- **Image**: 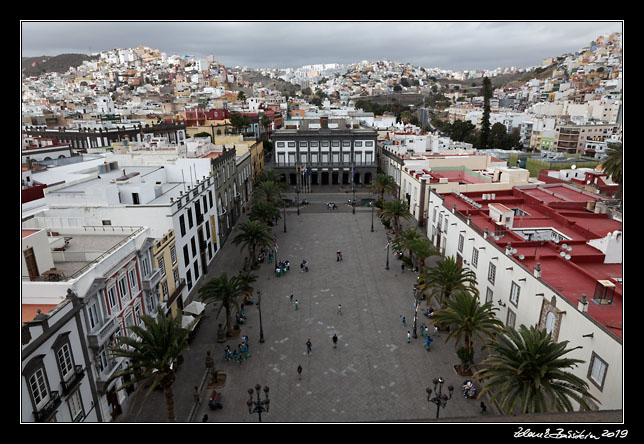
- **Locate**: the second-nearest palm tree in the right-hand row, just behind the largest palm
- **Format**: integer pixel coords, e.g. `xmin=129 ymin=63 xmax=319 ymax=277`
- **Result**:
xmin=432 ymin=291 xmax=503 ymax=370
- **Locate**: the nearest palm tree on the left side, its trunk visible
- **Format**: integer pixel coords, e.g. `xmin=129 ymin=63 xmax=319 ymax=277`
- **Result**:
xmin=108 ymin=312 xmax=196 ymax=422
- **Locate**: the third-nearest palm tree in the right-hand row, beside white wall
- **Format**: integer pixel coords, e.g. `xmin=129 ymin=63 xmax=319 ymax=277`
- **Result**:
xmin=419 ymin=256 xmax=479 ymax=306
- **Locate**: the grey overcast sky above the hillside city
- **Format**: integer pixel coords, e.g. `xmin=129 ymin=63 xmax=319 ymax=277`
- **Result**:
xmin=21 ymin=21 xmax=623 ymax=71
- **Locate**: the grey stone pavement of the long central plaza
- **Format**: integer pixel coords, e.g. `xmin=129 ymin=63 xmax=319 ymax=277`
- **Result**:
xmin=118 ymin=193 xmax=492 ymax=423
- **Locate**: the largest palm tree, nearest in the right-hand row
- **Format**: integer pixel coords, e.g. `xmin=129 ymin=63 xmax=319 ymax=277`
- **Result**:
xmin=474 ymin=325 xmax=597 ymax=414
